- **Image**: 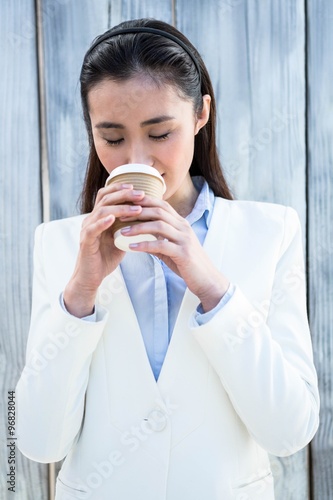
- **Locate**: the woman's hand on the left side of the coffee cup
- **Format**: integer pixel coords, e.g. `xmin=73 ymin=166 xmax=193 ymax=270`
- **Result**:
xmin=64 ymin=184 xmax=144 ymax=317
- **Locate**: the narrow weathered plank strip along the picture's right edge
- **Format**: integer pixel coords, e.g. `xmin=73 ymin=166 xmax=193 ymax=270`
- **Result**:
xmin=307 ymin=0 xmax=333 ymax=500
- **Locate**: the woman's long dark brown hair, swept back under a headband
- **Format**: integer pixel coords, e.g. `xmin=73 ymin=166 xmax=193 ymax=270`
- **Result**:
xmin=80 ymin=19 xmax=232 ymax=213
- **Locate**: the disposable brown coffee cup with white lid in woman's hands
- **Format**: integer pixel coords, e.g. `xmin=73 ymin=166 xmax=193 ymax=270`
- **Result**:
xmin=105 ymin=163 xmax=166 ymax=252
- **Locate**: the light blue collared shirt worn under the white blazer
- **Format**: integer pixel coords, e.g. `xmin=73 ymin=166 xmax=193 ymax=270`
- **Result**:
xmin=61 ymin=177 xmax=235 ymax=380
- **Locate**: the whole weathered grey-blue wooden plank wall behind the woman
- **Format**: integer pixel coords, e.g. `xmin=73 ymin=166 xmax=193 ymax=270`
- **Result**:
xmin=0 ymin=0 xmax=333 ymax=500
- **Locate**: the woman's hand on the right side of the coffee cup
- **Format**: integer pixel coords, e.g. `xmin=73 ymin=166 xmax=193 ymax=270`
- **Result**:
xmin=116 ymin=196 xmax=229 ymax=312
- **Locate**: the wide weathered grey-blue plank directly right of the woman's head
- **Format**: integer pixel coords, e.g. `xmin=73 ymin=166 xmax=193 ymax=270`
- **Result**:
xmin=176 ymin=0 xmax=309 ymax=500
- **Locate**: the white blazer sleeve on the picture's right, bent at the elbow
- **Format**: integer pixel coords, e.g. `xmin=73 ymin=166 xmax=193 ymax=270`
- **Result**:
xmin=190 ymin=207 xmax=319 ymax=456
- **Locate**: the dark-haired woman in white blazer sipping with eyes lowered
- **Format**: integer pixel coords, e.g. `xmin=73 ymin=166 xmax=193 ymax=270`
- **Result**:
xmin=17 ymin=19 xmax=319 ymax=500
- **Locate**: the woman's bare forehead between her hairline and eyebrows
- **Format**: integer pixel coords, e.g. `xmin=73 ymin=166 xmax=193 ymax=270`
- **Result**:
xmin=88 ymin=77 xmax=193 ymax=121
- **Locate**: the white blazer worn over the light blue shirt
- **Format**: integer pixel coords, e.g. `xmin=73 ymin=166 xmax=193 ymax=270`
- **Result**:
xmin=16 ymin=198 xmax=319 ymax=500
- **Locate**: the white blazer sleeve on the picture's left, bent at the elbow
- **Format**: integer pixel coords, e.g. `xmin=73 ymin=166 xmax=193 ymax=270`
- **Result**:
xmin=16 ymin=225 xmax=107 ymax=463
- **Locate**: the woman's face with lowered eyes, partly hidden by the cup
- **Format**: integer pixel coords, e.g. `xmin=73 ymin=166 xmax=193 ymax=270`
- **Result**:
xmin=88 ymin=77 xmax=210 ymax=209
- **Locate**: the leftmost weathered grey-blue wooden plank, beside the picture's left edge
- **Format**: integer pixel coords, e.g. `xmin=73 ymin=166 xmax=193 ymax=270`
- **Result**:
xmin=0 ymin=0 xmax=47 ymax=500
